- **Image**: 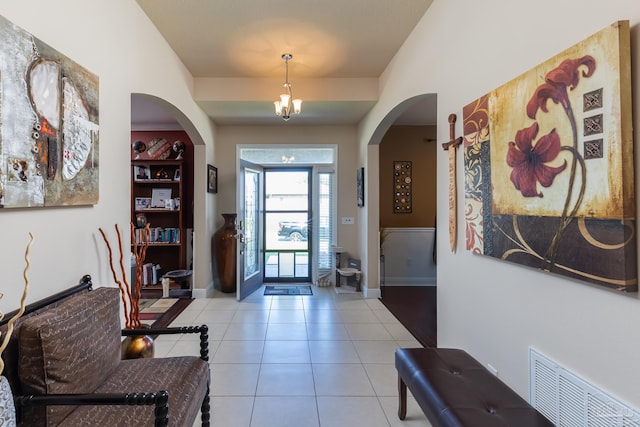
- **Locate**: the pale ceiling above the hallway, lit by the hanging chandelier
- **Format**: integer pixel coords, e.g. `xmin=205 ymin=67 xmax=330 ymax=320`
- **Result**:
xmin=132 ymin=0 xmax=435 ymax=126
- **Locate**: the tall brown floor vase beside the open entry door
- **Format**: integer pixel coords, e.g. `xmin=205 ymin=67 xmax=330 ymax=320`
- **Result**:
xmin=211 ymin=214 xmax=237 ymax=292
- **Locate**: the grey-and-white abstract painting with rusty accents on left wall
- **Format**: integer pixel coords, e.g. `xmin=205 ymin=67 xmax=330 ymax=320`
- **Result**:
xmin=0 ymin=16 xmax=99 ymax=208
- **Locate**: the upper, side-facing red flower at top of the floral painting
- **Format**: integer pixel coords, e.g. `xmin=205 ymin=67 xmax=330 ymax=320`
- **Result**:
xmin=527 ymin=55 xmax=596 ymax=119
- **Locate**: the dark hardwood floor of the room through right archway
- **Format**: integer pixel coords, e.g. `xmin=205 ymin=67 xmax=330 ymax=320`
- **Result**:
xmin=380 ymin=286 xmax=438 ymax=347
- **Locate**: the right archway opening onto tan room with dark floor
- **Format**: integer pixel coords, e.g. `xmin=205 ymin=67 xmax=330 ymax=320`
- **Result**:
xmin=369 ymin=94 xmax=438 ymax=346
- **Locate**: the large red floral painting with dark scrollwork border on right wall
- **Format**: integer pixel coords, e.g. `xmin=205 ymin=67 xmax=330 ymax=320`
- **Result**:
xmin=463 ymin=21 xmax=638 ymax=292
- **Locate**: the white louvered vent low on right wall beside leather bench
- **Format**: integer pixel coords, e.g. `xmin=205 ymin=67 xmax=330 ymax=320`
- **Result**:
xmin=529 ymin=348 xmax=640 ymax=427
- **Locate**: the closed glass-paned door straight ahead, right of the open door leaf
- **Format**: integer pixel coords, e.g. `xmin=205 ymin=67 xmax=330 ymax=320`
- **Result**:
xmin=264 ymin=168 xmax=312 ymax=282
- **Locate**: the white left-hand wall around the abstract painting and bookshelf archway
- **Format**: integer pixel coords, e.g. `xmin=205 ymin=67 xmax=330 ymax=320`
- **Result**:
xmin=0 ymin=0 xmax=214 ymax=311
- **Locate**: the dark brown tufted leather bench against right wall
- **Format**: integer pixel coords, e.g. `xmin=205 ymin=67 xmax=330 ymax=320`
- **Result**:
xmin=395 ymin=348 xmax=553 ymax=427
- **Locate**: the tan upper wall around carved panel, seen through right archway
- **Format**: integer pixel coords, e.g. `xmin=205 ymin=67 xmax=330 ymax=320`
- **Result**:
xmin=379 ymin=126 xmax=437 ymax=228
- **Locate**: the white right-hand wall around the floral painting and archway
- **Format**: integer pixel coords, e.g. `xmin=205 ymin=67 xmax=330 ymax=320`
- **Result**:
xmin=360 ymin=0 xmax=640 ymax=408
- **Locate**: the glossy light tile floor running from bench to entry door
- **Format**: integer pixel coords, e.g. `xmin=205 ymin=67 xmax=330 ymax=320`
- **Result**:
xmin=156 ymin=287 xmax=430 ymax=427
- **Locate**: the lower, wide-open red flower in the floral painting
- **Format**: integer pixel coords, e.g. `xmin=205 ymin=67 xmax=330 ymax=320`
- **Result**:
xmin=507 ymin=122 xmax=567 ymax=197
